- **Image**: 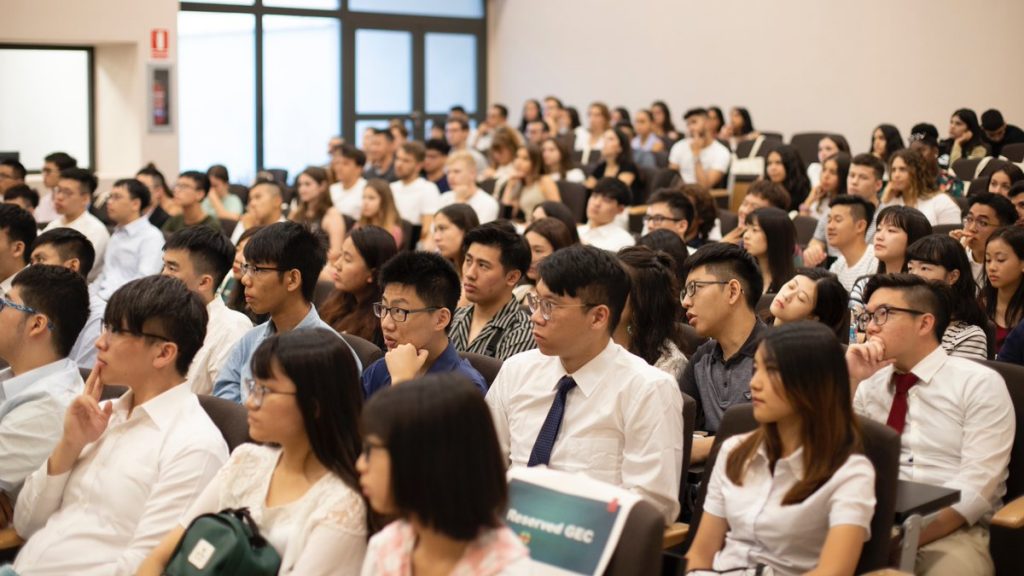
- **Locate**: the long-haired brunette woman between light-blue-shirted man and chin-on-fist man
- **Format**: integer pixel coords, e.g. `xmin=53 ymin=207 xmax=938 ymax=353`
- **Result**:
xmin=317 ymin=225 xmax=398 ymax=348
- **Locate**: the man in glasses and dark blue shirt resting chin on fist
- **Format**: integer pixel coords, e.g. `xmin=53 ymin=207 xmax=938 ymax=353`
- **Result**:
xmin=362 ymin=252 xmax=487 ymax=398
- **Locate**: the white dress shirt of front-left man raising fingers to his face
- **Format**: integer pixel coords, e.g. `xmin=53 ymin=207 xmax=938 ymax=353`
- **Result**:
xmin=14 ymin=383 xmax=227 ymax=576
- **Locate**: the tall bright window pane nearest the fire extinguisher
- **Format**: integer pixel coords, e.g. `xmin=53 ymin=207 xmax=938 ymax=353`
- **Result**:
xmin=179 ymin=12 xmax=256 ymax=182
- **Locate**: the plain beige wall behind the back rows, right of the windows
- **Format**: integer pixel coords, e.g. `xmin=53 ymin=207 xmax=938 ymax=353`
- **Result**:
xmin=488 ymin=0 xmax=1024 ymax=147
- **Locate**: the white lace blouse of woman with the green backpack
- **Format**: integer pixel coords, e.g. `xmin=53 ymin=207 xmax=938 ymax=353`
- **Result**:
xmin=181 ymin=444 xmax=368 ymax=576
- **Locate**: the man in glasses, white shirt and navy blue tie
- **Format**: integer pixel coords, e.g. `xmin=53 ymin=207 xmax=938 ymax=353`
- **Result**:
xmin=487 ymin=246 xmax=683 ymax=524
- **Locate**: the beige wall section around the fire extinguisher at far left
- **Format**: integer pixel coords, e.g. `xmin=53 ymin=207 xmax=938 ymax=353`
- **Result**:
xmin=0 ymin=0 xmax=178 ymax=181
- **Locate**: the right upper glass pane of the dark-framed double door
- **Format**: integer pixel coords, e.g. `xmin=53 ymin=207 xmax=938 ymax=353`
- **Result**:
xmin=425 ymin=33 xmax=476 ymax=114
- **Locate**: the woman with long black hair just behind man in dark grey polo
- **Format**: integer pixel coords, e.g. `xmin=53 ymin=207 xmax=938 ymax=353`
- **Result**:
xmin=743 ymin=206 xmax=797 ymax=294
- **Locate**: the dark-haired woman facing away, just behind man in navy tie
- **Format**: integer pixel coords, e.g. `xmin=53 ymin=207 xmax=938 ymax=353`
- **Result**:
xmin=612 ymin=246 xmax=686 ymax=380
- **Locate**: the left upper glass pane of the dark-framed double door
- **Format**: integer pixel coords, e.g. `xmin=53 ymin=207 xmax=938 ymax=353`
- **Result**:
xmin=355 ymin=30 xmax=413 ymax=114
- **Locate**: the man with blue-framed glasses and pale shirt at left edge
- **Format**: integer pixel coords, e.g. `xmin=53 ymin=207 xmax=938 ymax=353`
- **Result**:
xmin=0 ymin=265 xmax=89 ymax=512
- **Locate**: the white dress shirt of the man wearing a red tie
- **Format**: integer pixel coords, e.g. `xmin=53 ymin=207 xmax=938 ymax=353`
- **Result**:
xmin=853 ymin=346 xmax=1016 ymax=525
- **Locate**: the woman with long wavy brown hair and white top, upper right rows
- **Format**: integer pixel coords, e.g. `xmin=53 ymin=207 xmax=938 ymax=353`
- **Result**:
xmin=879 ymin=148 xmax=961 ymax=225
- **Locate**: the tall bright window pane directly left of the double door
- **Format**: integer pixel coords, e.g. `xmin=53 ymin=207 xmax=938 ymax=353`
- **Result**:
xmin=263 ymin=15 xmax=341 ymax=177
